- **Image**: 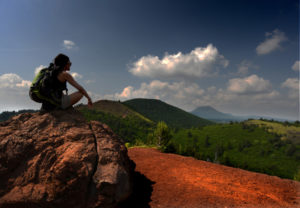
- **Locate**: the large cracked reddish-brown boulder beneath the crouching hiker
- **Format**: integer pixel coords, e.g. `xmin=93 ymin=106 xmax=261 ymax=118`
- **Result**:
xmin=0 ymin=109 xmax=134 ymax=208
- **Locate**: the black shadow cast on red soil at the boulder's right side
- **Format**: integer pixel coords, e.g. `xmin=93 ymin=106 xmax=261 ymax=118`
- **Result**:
xmin=118 ymin=171 xmax=155 ymax=208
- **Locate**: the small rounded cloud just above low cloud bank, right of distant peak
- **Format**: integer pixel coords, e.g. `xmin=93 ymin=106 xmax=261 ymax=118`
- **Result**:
xmin=227 ymin=74 xmax=272 ymax=94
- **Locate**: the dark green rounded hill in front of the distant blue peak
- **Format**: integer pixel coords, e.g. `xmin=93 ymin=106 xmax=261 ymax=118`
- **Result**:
xmin=123 ymin=98 xmax=213 ymax=128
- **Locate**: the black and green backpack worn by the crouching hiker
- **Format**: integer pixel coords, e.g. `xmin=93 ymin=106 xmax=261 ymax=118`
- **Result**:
xmin=29 ymin=64 xmax=68 ymax=108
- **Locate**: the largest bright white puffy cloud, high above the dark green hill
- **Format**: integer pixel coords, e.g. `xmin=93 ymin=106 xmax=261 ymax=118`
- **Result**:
xmin=129 ymin=44 xmax=229 ymax=78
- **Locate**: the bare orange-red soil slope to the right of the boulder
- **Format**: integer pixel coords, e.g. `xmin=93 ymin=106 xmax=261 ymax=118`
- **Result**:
xmin=123 ymin=148 xmax=300 ymax=208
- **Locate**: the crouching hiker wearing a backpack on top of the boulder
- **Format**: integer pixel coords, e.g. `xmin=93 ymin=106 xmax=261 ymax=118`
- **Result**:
xmin=29 ymin=54 xmax=93 ymax=110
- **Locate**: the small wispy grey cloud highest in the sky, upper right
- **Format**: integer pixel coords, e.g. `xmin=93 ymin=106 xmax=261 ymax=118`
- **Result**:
xmin=256 ymin=29 xmax=287 ymax=55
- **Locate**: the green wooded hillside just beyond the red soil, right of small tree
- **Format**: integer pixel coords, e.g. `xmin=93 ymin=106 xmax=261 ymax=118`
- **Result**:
xmin=167 ymin=121 xmax=300 ymax=180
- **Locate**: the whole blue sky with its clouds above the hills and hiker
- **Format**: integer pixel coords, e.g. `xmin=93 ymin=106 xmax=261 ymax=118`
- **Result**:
xmin=0 ymin=0 xmax=299 ymax=120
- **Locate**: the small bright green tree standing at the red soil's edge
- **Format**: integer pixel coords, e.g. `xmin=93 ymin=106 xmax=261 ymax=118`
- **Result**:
xmin=154 ymin=121 xmax=171 ymax=146
